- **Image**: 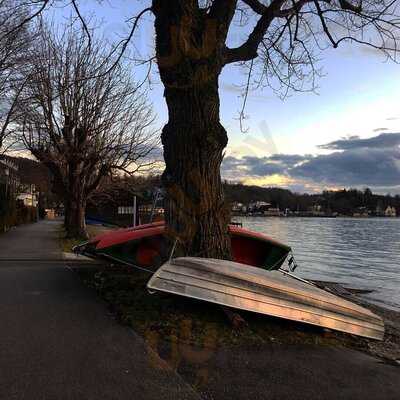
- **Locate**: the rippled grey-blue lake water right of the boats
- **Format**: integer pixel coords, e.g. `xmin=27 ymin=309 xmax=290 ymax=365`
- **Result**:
xmin=235 ymin=217 xmax=400 ymax=310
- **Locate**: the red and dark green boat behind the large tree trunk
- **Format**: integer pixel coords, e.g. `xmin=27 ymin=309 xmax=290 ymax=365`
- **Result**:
xmin=74 ymin=221 xmax=291 ymax=270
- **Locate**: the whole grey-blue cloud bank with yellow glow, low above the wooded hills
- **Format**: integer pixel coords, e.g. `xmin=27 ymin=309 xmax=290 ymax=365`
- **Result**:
xmin=222 ymin=133 xmax=400 ymax=193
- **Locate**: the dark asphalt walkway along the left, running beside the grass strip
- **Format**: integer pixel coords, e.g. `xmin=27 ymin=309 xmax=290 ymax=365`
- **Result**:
xmin=0 ymin=221 xmax=198 ymax=400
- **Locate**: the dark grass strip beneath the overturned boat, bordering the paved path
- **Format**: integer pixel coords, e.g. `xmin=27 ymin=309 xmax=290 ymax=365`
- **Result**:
xmin=73 ymin=266 xmax=368 ymax=354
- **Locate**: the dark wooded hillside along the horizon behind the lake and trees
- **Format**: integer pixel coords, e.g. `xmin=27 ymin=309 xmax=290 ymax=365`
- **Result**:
xmin=4 ymin=157 xmax=400 ymax=215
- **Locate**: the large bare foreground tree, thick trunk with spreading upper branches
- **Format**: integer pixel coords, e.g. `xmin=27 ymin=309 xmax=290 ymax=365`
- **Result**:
xmin=9 ymin=0 xmax=400 ymax=258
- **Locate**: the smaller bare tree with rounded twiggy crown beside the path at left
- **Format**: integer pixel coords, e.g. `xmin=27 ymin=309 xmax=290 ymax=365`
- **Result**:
xmin=18 ymin=22 xmax=157 ymax=237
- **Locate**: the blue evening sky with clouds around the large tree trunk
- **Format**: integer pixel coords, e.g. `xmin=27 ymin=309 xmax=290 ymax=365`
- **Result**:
xmin=52 ymin=0 xmax=400 ymax=194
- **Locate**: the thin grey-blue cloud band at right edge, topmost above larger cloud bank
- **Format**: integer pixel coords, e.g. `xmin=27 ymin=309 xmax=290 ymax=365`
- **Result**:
xmin=318 ymin=133 xmax=400 ymax=150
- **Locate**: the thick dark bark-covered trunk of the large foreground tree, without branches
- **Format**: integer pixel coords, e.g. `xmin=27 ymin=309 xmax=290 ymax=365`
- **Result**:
xmin=152 ymin=0 xmax=235 ymax=258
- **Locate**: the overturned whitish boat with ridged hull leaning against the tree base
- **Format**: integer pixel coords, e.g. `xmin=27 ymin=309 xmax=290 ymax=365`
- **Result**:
xmin=147 ymin=257 xmax=384 ymax=340
